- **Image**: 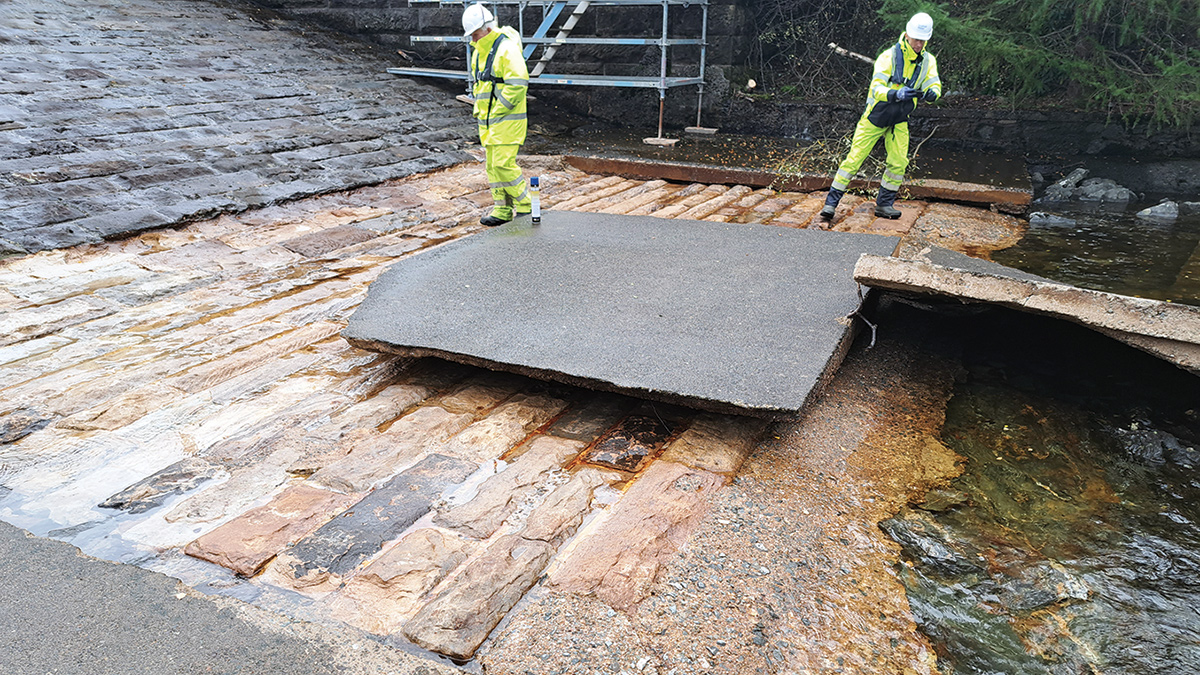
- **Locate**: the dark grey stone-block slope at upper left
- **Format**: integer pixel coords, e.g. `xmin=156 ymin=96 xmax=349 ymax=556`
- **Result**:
xmin=0 ymin=0 xmax=475 ymax=255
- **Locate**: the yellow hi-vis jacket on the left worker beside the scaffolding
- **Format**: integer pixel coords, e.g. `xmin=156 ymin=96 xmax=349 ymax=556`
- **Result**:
xmin=470 ymin=26 xmax=529 ymax=145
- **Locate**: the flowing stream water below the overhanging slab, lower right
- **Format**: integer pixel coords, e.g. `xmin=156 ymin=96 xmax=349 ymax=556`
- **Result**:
xmin=881 ymin=310 xmax=1200 ymax=674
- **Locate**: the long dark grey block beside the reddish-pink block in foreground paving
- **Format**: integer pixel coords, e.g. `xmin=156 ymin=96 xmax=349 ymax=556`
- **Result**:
xmin=287 ymin=454 xmax=476 ymax=579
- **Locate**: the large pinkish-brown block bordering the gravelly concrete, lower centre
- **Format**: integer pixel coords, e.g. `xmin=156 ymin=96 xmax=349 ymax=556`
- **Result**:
xmin=551 ymin=461 xmax=725 ymax=610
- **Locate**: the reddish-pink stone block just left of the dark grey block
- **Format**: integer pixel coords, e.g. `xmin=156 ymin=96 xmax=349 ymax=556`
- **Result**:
xmin=184 ymin=485 xmax=356 ymax=577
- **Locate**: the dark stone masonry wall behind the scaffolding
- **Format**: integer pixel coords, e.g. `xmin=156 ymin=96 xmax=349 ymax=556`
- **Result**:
xmin=244 ymin=0 xmax=754 ymax=129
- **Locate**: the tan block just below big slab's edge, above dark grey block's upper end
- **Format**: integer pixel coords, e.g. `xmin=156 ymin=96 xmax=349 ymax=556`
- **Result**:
xmin=442 ymin=394 xmax=566 ymax=462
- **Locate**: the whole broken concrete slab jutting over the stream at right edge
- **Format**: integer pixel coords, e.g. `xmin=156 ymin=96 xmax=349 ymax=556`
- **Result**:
xmin=854 ymin=249 xmax=1200 ymax=375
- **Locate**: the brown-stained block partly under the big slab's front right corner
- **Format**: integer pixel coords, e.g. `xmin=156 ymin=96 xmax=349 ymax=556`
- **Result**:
xmin=659 ymin=413 xmax=768 ymax=478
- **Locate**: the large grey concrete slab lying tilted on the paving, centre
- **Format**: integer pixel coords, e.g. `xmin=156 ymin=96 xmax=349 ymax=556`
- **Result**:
xmin=343 ymin=211 xmax=898 ymax=418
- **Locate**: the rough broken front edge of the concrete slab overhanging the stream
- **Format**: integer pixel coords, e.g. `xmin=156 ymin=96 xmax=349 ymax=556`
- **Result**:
xmin=854 ymin=253 xmax=1200 ymax=345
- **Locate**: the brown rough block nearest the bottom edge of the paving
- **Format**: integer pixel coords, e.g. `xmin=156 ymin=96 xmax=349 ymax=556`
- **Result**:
xmin=403 ymin=534 xmax=554 ymax=658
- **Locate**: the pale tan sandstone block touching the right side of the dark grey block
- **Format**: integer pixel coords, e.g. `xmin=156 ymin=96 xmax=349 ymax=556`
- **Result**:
xmin=433 ymin=436 xmax=584 ymax=539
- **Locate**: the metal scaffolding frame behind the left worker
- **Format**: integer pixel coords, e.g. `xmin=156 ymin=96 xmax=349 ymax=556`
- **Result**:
xmin=388 ymin=0 xmax=709 ymax=139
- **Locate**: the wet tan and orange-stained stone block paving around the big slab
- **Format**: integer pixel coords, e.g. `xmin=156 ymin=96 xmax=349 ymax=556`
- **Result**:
xmin=0 ymin=141 xmax=1015 ymax=673
